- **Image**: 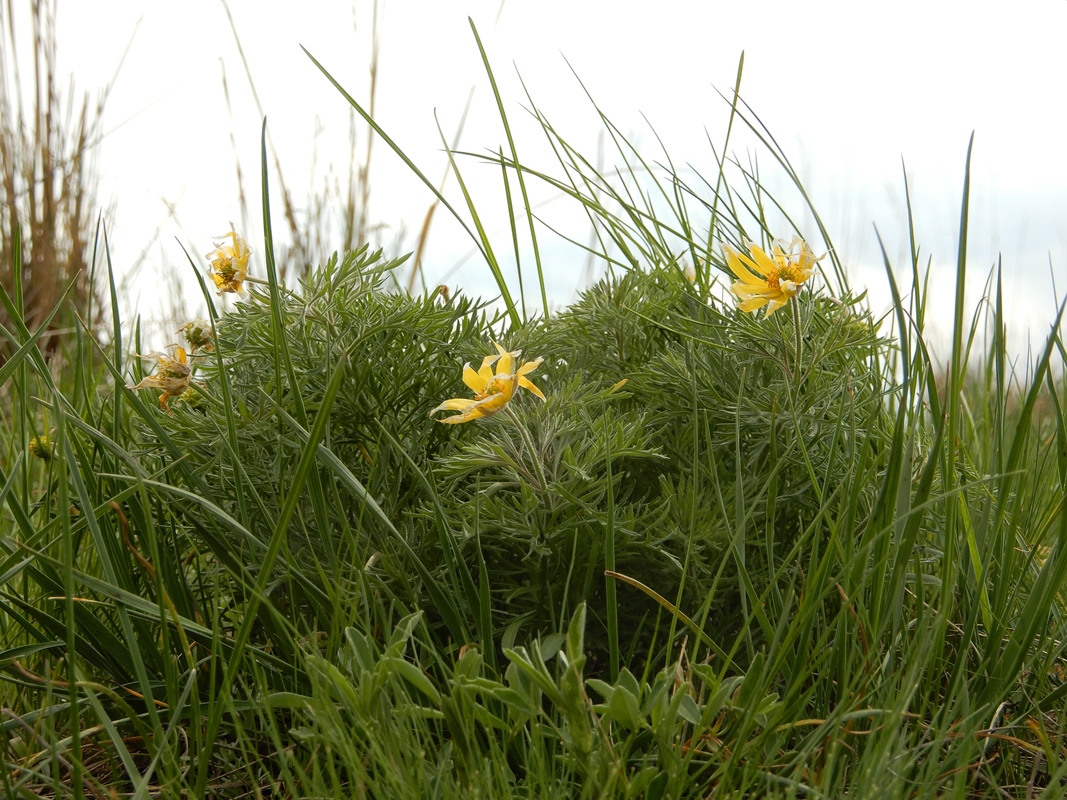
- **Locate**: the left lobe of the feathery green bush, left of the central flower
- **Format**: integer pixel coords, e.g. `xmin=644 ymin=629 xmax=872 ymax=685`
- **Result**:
xmin=137 ymin=250 xmax=490 ymax=582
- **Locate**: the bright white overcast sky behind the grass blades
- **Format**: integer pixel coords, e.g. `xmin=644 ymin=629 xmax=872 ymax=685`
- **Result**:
xmin=22 ymin=0 xmax=1067 ymax=343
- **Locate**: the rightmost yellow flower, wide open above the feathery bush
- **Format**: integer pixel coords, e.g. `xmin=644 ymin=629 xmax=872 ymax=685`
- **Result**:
xmin=720 ymin=236 xmax=826 ymax=317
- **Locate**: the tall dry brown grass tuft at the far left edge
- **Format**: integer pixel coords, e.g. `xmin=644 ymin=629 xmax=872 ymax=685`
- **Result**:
xmin=0 ymin=0 xmax=107 ymax=362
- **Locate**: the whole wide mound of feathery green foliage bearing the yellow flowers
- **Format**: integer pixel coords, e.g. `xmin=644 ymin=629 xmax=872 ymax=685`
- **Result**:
xmin=118 ymin=233 xmax=889 ymax=691
